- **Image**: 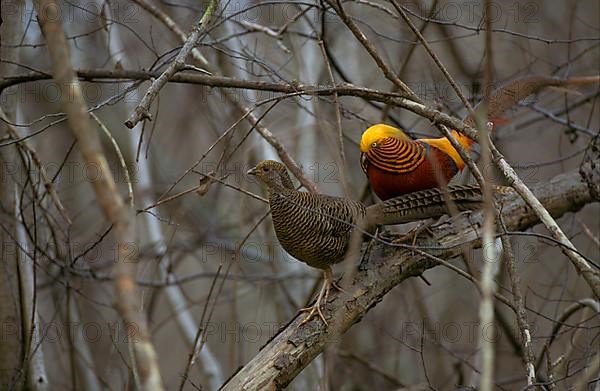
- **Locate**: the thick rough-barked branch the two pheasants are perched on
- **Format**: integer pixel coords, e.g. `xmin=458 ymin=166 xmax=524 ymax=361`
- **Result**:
xmin=222 ymin=164 xmax=598 ymax=390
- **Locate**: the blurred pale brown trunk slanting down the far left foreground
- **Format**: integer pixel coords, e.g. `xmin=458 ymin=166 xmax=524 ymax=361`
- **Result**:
xmin=34 ymin=0 xmax=163 ymax=390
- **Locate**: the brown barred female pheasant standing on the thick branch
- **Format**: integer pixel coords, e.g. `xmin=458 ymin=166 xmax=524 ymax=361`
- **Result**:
xmin=248 ymin=160 xmax=482 ymax=324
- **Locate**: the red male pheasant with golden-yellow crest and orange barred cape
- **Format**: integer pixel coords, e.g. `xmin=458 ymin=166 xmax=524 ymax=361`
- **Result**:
xmin=360 ymin=76 xmax=600 ymax=200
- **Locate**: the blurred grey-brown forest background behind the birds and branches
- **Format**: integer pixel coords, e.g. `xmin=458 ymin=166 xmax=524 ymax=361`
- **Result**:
xmin=0 ymin=0 xmax=600 ymax=390
